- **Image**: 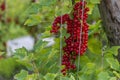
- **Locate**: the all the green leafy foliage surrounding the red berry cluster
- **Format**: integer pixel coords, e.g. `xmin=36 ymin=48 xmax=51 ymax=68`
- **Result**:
xmin=0 ymin=0 xmax=120 ymax=80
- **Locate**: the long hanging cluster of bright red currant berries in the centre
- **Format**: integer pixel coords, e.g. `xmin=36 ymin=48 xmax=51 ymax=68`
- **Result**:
xmin=50 ymin=1 xmax=89 ymax=75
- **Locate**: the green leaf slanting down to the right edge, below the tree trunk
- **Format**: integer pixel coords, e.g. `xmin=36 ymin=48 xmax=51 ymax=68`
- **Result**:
xmin=106 ymin=58 xmax=120 ymax=71
